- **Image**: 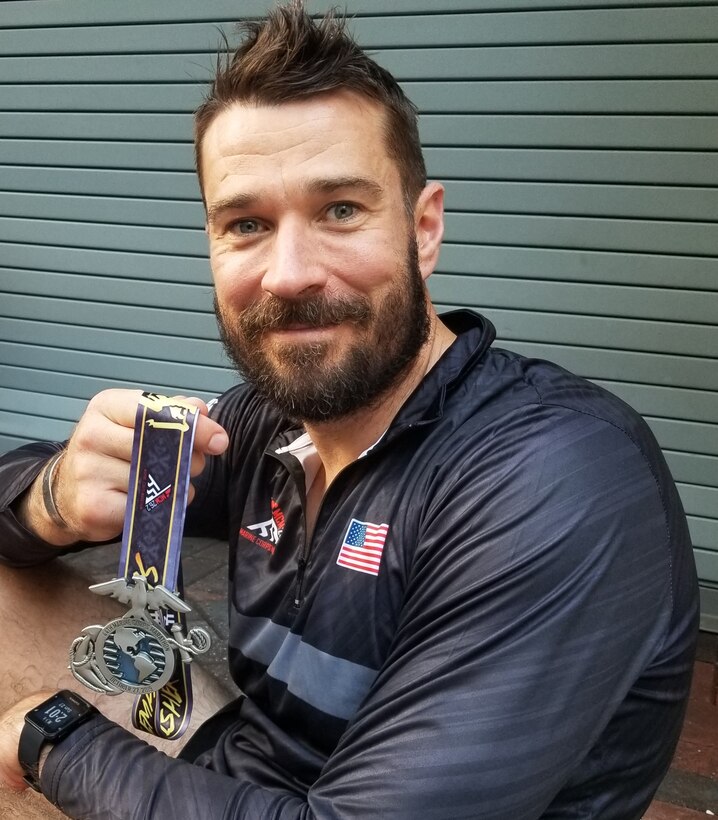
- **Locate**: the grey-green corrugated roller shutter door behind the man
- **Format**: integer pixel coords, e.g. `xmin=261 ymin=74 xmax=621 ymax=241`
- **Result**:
xmin=0 ymin=0 xmax=718 ymax=628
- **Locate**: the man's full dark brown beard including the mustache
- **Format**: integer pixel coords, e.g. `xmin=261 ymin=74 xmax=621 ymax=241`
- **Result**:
xmin=214 ymin=236 xmax=430 ymax=422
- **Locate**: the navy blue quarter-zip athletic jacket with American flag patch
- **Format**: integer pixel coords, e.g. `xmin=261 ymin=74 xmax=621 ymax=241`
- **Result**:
xmin=0 ymin=311 xmax=698 ymax=820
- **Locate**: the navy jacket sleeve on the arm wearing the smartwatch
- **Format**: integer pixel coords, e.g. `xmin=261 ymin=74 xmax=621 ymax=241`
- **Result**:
xmin=42 ymin=406 xmax=696 ymax=820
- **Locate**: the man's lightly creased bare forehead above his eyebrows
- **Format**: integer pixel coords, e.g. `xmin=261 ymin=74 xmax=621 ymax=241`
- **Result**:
xmin=201 ymin=91 xmax=399 ymax=201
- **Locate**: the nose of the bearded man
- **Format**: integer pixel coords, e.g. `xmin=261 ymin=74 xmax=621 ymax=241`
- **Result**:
xmin=262 ymin=220 xmax=327 ymax=299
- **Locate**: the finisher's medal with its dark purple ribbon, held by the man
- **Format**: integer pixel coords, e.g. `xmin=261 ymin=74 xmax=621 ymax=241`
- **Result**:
xmin=70 ymin=393 xmax=210 ymax=739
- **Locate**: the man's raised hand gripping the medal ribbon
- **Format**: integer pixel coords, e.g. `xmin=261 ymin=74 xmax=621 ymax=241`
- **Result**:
xmin=18 ymin=390 xmax=229 ymax=546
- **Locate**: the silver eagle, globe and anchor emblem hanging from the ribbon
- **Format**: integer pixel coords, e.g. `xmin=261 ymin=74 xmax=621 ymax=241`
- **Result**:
xmin=70 ymin=573 xmax=210 ymax=695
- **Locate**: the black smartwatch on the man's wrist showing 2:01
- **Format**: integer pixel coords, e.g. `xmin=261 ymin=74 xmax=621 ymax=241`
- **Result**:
xmin=17 ymin=689 xmax=97 ymax=792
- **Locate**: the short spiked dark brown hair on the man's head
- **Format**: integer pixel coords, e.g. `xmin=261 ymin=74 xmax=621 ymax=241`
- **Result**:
xmin=194 ymin=0 xmax=426 ymax=211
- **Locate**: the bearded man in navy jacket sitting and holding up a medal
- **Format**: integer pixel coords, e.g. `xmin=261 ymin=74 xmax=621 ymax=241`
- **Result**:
xmin=0 ymin=2 xmax=697 ymax=820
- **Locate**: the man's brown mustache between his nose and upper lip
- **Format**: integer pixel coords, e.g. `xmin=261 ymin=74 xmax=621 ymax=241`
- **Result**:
xmin=238 ymin=295 xmax=371 ymax=338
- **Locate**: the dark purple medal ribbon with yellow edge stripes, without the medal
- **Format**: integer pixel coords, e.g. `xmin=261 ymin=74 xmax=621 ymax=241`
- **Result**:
xmin=118 ymin=393 xmax=199 ymax=740
